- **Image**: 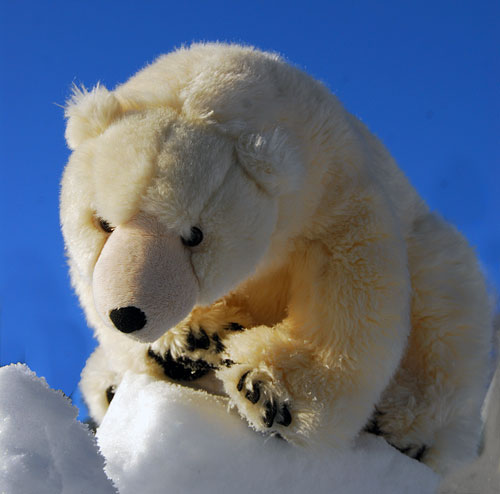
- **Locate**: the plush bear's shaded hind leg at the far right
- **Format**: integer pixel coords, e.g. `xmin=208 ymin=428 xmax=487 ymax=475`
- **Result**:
xmin=368 ymin=214 xmax=492 ymax=473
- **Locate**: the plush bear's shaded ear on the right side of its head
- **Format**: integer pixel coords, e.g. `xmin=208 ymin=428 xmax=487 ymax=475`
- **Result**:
xmin=236 ymin=128 xmax=304 ymax=196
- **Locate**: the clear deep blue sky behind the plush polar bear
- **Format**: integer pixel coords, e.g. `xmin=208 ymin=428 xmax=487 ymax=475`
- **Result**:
xmin=0 ymin=0 xmax=500 ymax=414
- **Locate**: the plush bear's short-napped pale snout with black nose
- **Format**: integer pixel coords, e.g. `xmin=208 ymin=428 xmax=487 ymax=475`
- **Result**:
xmin=92 ymin=214 xmax=199 ymax=342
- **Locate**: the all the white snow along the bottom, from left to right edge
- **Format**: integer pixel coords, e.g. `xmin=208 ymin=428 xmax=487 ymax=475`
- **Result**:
xmin=11 ymin=364 xmax=492 ymax=494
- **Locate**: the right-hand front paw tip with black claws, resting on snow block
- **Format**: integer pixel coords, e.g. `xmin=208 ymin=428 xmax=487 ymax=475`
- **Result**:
xmin=218 ymin=365 xmax=293 ymax=433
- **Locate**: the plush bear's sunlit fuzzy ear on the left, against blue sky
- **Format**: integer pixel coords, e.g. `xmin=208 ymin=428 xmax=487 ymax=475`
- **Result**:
xmin=64 ymin=84 xmax=123 ymax=150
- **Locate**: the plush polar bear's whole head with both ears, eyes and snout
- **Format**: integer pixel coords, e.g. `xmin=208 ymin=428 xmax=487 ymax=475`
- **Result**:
xmin=61 ymin=47 xmax=316 ymax=342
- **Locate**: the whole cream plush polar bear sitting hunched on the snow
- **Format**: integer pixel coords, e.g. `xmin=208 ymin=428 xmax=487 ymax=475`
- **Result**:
xmin=61 ymin=44 xmax=492 ymax=473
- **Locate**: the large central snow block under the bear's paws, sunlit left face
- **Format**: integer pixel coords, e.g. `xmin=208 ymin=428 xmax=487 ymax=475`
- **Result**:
xmin=97 ymin=374 xmax=439 ymax=494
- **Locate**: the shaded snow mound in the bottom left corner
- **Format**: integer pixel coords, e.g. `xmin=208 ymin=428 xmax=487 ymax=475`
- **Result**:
xmin=0 ymin=364 xmax=116 ymax=494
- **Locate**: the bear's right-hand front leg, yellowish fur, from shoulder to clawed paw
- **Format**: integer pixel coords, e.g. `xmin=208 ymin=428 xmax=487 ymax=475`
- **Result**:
xmin=216 ymin=210 xmax=410 ymax=447
